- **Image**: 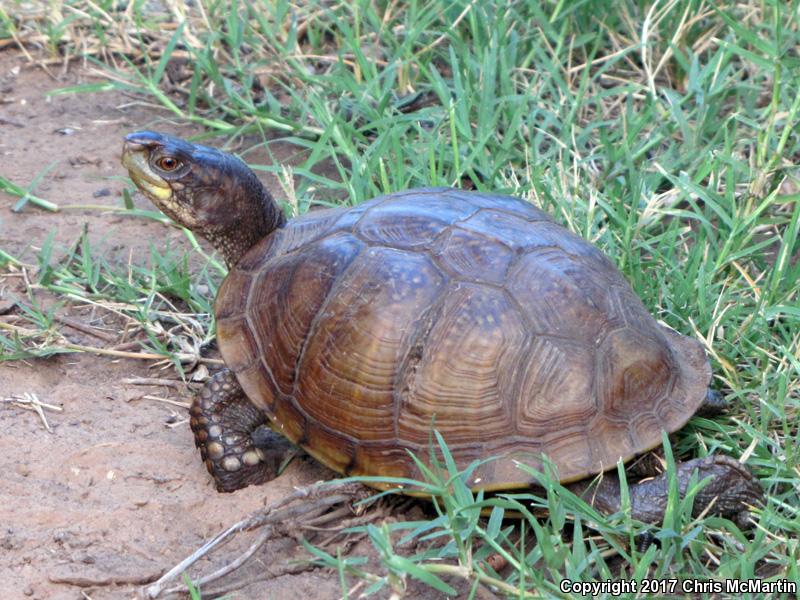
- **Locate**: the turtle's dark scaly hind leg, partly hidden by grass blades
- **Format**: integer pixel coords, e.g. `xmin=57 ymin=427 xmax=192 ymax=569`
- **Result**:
xmin=568 ymin=455 xmax=764 ymax=528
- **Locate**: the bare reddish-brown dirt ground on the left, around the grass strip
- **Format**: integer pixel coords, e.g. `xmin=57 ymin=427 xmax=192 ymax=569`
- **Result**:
xmin=0 ymin=50 xmax=390 ymax=600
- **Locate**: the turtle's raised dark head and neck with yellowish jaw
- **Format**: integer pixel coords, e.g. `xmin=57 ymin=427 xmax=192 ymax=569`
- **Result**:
xmin=122 ymin=131 xmax=284 ymax=266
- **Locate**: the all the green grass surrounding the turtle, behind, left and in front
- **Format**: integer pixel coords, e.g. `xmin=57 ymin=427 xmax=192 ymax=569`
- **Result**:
xmin=0 ymin=0 xmax=800 ymax=597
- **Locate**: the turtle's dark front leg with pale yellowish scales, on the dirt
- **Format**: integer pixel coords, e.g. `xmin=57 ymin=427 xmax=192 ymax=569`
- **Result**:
xmin=189 ymin=369 xmax=292 ymax=492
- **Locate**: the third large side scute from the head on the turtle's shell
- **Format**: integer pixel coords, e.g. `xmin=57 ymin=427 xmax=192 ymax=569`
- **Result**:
xmin=398 ymin=284 xmax=525 ymax=444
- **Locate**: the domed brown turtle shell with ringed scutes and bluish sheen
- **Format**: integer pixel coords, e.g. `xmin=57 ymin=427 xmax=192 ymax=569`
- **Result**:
xmin=216 ymin=188 xmax=710 ymax=490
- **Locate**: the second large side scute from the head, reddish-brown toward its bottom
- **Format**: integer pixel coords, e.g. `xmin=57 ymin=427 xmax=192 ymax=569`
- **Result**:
xmin=295 ymin=247 xmax=445 ymax=440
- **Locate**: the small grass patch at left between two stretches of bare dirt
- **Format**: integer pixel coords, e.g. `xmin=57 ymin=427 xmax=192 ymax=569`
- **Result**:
xmin=0 ymin=226 xmax=219 ymax=374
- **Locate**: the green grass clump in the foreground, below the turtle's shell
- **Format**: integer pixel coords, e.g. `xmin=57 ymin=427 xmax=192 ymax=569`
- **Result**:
xmin=306 ymin=432 xmax=776 ymax=598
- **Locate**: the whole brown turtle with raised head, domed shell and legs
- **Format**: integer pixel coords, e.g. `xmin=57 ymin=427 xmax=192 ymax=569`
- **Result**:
xmin=122 ymin=131 xmax=762 ymax=521
